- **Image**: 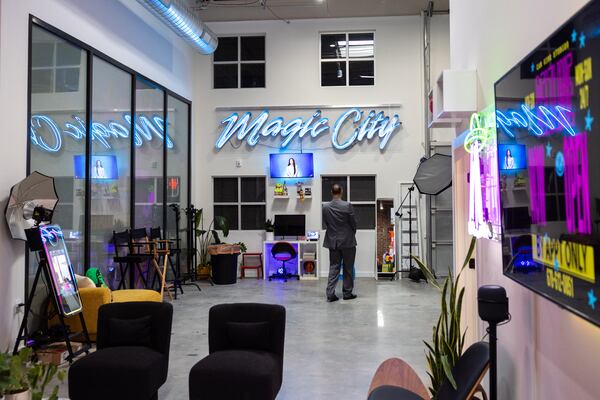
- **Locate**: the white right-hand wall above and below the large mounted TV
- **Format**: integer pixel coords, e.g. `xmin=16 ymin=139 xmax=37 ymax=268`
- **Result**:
xmin=450 ymin=0 xmax=600 ymax=400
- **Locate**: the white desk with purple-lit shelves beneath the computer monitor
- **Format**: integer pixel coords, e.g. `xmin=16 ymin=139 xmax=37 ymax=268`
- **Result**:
xmin=263 ymin=240 xmax=321 ymax=280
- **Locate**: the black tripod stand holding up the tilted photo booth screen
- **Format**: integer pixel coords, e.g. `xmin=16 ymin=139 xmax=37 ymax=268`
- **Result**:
xmin=13 ymin=241 xmax=91 ymax=363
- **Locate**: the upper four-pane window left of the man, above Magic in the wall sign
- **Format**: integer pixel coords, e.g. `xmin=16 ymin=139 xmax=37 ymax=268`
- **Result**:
xmin=213 ymin=36 xmax=265 ymax=89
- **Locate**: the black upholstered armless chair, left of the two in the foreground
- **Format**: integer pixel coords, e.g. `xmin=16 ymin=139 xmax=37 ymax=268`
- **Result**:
xmin=69 ymin=302 xmax=173 ymax=400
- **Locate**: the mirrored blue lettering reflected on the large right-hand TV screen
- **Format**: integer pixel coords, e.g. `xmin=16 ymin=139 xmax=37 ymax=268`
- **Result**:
xmin=496 ymin=104 xmax=576 ymax=137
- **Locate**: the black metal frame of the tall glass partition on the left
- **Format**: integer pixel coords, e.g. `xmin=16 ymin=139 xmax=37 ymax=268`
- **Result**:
xmin=25 ymin=14 xmax=192 ymax=296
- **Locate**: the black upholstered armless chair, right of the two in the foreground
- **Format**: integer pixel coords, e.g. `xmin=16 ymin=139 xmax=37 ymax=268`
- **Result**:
xmin=189 ymin=303 xmax=285 ymax=400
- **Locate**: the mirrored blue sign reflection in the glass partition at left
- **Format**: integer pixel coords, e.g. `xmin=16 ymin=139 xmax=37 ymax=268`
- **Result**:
xmin=29 ymin=114 xmax=174 ymax=153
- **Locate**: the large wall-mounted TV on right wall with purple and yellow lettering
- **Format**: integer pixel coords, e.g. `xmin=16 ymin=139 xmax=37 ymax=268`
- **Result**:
xmin=495 ymin=0 xmax=600 ymax=325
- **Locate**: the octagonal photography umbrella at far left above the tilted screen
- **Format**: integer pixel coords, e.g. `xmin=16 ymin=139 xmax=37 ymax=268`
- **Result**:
xmin=4 ymin=171 xmax=58 ymax=240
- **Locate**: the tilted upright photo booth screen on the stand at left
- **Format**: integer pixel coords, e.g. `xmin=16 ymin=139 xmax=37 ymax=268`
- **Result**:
xmin=40 ymin=225 xmax=81 ymax=315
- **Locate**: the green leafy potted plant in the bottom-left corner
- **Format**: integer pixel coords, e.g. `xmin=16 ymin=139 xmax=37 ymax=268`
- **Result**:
xmin=0 ymin=347 xmax=65 ymax=400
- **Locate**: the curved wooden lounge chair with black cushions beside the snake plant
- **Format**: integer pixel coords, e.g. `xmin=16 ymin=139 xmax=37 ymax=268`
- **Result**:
xmin=368 ymin=342 xmax=490 ymax=400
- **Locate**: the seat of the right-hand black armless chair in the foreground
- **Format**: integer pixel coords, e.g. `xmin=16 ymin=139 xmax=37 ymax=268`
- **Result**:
xmin=190 ymin=350 xmax=282 ymax=400
